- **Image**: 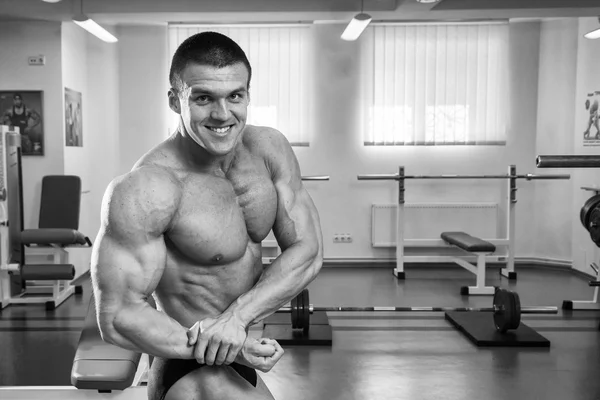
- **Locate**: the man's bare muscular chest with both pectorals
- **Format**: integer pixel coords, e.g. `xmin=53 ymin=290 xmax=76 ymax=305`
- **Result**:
xmin=169 ymin=159 xmax=277 ymax=259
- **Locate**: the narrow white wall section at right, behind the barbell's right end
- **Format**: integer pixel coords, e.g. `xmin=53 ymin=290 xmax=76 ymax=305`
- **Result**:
xmin=534 ymin=18 xmax=578 ymax=262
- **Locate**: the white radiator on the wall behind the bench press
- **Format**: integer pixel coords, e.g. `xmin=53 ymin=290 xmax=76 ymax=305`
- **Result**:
xmin=371 ymin=203 xmax=499 ymax=247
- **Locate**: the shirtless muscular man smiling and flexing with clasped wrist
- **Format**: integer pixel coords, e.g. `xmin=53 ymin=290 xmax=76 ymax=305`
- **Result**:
xmin=92 ymin=32 xmax=322 ymax=400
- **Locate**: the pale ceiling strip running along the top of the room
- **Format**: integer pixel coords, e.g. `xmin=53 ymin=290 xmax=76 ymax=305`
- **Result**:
xmin=0 ymin=0 xmax=600 ymax=24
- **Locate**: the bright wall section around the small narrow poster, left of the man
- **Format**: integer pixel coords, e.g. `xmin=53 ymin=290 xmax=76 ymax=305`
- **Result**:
xmin=62 ymin=22 xmax=119 ymax=276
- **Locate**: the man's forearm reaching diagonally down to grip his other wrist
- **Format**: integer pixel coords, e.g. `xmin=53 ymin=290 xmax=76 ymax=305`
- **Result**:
xmin=225 ymin=244 xmax=322 ymax=326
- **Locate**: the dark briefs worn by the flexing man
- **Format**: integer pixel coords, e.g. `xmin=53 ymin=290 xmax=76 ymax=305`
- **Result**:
xmin=148 ymin=357 xmax=258 ymax=400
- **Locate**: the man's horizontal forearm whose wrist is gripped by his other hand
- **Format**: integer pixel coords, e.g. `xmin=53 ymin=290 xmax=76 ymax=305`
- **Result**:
xmin=100 ymin=303 xmax=194 ymax=359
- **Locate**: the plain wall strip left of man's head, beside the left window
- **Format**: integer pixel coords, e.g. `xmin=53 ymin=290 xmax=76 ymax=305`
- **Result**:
xmin=117 ymin=26 xmax=170 ymax=174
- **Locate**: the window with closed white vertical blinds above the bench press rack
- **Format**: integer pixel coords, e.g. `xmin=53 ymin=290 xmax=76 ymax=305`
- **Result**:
xmin=359 ymin=23 xmax=508 ymax=145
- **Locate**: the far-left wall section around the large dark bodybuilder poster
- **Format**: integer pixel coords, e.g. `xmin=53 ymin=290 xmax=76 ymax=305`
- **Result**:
xmin=0 ymin=21 xmax=64 ymax=228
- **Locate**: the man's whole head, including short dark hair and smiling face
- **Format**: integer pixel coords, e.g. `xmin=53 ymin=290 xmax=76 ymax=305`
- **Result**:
xmin=169 ymin=32 xmax=251 ymax=156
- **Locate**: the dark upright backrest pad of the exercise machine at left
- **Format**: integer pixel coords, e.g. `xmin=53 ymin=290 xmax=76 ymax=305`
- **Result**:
xmin=38 ymin=175 xmax=81 ymax=230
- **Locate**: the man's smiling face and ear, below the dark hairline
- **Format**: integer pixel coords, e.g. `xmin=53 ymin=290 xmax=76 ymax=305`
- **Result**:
xmin=169 ymin=63 xmax=249 ymax=156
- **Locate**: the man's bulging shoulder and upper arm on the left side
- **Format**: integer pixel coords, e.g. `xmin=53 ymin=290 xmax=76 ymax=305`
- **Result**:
xmin=92 ymin=172 xmax=176 ymax=313
